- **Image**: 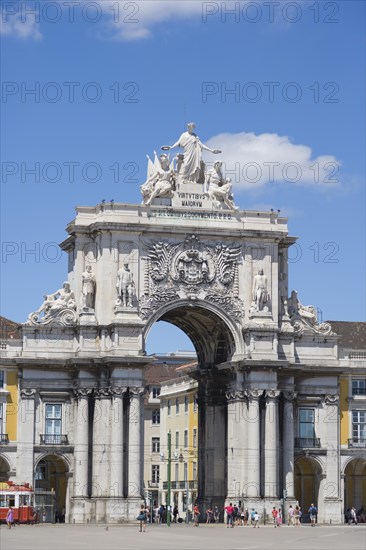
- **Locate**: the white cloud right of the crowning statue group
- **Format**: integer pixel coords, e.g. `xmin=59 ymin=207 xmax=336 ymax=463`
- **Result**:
xmin=205 ymin=132 xmax=341 ymax=190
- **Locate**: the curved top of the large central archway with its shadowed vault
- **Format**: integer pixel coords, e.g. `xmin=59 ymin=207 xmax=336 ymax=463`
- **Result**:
xmin=144 ymin=300 xmax=244 ymax=367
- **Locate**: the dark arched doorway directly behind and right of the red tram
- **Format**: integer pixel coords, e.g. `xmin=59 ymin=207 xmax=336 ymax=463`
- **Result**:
xmin=35 ymin=453 xmax=70 ymax=523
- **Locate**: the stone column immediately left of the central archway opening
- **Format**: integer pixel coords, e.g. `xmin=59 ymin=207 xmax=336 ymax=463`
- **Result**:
xmin=128 ymin=388 xmax=145 ymax=499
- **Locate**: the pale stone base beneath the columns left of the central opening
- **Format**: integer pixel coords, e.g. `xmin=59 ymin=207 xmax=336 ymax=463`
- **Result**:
xmin=67 ymin=497 xmax=143 ymax=524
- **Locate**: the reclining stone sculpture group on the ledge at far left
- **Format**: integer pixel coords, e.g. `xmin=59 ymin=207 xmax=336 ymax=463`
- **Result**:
xmin=27 ymin=281 xmax=78 ymax=326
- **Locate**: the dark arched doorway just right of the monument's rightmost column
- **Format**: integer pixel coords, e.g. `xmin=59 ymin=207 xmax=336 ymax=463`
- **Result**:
xmin=295 ymin=455 xmax=324 ymax=522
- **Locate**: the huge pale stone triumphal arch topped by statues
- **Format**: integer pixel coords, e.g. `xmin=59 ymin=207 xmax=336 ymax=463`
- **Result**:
xmin=18 ymin=124 xmax=341 ymax=522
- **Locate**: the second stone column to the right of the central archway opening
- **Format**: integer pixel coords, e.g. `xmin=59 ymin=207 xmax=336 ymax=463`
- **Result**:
xmin=246 ymin=389 xmax=263 ymax=498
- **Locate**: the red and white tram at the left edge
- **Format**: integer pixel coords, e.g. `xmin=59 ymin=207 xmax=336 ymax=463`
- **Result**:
xmin=0 ymin=481 xmax=36 ymax=523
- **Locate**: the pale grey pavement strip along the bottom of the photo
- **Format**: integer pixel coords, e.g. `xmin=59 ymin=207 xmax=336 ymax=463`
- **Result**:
xmin=0 ymin=524 xmax=366 ymax=550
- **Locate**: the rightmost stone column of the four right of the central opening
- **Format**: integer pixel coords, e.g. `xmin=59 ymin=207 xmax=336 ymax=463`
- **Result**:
xmin=279 ymin=391 xmax=297 ymax=501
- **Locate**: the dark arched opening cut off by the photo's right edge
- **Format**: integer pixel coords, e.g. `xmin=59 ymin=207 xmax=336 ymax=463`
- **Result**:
xmin=343 ymin=457 xmax=366 ymax=511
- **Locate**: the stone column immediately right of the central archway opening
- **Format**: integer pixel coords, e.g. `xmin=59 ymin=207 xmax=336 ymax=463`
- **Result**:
xmin=226 ymin=389 xmax=246 ymax=501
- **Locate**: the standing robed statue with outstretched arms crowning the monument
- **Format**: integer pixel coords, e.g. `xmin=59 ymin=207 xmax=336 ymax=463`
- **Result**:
xmin=162 ymin=122 xmax=221 ymax=183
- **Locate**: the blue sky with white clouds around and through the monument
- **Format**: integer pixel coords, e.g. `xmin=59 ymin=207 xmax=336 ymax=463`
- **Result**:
xmin=1 ymin=0 xmax=365 ymax=352
